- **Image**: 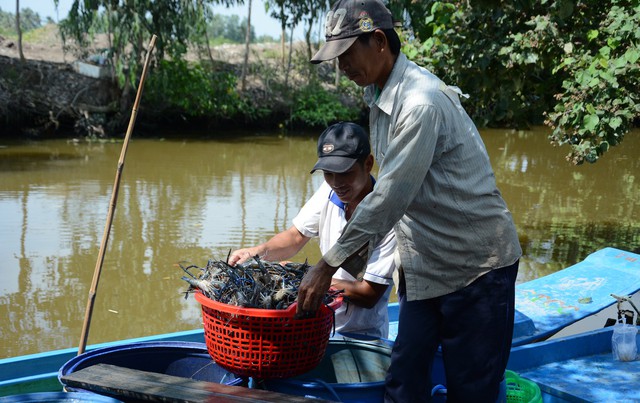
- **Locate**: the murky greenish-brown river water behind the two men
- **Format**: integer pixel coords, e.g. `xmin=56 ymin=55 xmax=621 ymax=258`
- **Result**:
xmin=0 ymin=128 xmax=640 ymax=358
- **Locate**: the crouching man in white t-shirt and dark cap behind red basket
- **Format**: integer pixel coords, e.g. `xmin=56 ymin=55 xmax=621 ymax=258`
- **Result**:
xmin=229 ymin=122 xmax=396 ymax=338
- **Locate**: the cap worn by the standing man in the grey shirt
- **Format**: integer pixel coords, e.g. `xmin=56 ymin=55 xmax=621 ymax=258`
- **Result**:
xmin=311 ymin=0 xmax=393 ymax=64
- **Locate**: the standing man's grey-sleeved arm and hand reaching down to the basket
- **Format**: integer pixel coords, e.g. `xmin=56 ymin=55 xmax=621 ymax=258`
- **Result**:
xmin=298 ymin=106 xmax=442 ymax=313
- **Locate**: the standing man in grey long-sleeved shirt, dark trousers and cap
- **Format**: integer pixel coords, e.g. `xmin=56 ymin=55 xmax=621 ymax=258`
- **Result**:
xmin=298 ymin=0 xmax=522 ymax=403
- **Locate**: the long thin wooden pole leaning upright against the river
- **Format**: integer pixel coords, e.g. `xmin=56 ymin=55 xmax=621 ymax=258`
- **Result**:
xmin=78 ymin=34 xmax=156 ymax=355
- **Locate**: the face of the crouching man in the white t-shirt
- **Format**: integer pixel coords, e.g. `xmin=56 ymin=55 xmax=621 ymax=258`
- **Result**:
xmin=323 ymin=155 xmax=373 ymax=203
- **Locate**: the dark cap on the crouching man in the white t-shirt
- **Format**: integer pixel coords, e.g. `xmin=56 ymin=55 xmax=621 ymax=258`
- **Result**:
xmin=311 ymin=122 xmax=371 ymax=173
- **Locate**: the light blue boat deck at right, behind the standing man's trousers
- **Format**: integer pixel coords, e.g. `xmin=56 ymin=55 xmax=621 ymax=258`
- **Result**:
xmin=513 ymin=248 xmax=640 ymax=346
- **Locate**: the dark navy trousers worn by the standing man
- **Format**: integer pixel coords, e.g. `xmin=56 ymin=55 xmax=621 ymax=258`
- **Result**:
xmin=385 ymin=261 xmax=519 ymax=403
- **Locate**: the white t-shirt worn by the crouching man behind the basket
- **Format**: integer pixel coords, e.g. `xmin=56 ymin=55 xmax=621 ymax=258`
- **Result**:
xmin=293 ymin=182 xmax=396 ymax=338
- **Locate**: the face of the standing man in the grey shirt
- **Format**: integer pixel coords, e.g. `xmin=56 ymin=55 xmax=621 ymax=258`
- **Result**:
xmin=338 ymin=35 xmax=381 ymax=87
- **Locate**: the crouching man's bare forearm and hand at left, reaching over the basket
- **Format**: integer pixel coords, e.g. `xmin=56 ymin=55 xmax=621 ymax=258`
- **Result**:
xmin=228 ymin=226 xmax=311 ymax=266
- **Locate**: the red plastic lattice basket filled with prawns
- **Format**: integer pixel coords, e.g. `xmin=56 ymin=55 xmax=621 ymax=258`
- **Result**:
xmin=195 ymin=292 xmax=342 ymax=379
